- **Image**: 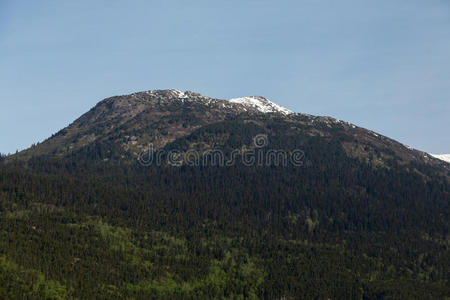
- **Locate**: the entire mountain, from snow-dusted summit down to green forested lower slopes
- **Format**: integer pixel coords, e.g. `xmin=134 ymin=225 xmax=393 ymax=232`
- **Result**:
xmin=0 ymin=90 xmax=450 ymax=299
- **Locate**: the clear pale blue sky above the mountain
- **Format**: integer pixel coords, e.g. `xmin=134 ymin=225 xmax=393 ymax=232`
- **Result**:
xmin=0 ymin=0 xmax=450 ymax=153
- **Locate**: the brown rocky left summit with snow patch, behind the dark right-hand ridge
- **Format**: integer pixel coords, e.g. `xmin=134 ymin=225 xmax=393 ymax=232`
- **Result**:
xmin=14 ymin=90 xmax=288 ymax=156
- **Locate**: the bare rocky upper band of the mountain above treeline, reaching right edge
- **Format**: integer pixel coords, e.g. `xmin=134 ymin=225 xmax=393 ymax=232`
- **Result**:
xmin=12 ymin=90 xmax=450 ymax=172
